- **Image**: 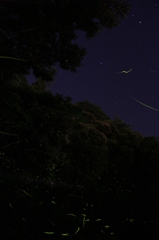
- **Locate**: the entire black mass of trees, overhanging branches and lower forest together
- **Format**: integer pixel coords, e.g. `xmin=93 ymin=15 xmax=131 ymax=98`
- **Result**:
xmin=0 ymin=0 xmax=159 ymax=240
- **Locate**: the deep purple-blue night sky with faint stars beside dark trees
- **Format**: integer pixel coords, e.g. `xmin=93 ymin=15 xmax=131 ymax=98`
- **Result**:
xmin=27 ymin=0 xmax=159 ymax=137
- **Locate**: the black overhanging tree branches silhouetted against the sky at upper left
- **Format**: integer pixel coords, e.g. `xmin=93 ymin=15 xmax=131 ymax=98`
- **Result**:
xmin=0 ymin=0 xmax=130 ymax=81
